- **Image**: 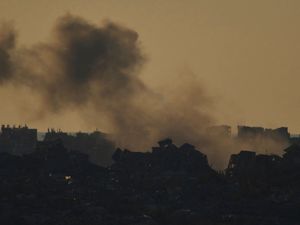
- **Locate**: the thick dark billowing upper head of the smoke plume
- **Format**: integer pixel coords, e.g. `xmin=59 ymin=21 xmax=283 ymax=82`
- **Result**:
xmin=18 ymin=15 xmax=143 ymax=111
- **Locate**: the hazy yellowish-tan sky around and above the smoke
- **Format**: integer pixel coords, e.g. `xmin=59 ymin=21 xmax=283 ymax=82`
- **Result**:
xmin=0 ymin=0 xmax=300 ymax=133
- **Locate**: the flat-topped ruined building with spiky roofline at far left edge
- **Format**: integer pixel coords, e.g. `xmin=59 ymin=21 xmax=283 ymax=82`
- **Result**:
xmin=0 ymin=125 xmax=37 ymax=155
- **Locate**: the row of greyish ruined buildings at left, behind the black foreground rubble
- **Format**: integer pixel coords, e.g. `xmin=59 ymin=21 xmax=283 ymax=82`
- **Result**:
xmin=0 ymin=125 xmax=115 ymax=166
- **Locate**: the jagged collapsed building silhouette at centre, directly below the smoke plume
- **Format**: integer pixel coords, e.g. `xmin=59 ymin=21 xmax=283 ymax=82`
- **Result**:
xmin=112 ymin=138 xmax=215 ymax=176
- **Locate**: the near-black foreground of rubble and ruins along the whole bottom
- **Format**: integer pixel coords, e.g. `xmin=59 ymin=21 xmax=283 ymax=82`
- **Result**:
xmin=0 ymin=139 xmax=300 ymax=225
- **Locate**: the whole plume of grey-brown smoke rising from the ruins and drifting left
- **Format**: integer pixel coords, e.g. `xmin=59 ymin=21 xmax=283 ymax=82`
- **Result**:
xmin=0 ymin=14 xmax=213 ymax=149
